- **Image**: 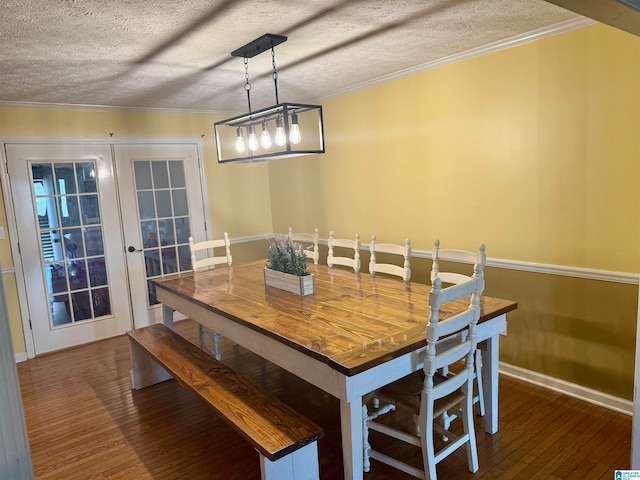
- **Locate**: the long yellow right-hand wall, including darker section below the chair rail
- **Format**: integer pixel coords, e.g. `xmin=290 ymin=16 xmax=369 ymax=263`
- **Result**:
xmin=269 ymin=25 xmax=640 ymax=399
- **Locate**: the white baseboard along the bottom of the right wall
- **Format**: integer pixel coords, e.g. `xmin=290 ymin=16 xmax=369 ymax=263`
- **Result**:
xmin=499 ymin=362 xmax=633 ymax=415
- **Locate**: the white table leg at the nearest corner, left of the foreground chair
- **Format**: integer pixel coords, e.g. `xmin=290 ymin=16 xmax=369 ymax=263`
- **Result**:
xmin=340 ymin=397 xmax=363 ymax=480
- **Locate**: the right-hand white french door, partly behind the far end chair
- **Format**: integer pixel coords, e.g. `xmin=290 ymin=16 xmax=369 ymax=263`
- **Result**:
xmin=114 ymin=144 xmax=205 ymax=327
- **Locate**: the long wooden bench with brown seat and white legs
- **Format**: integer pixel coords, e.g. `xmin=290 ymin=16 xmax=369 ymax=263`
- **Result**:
xmin=127 ymin=324 xmax=324 ymax=480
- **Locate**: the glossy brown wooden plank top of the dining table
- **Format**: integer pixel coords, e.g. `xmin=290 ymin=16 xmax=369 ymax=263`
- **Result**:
xmin=154 ymin=260 xmax=517 ymax=376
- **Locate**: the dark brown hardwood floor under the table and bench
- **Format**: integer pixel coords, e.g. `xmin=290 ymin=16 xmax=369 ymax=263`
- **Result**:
xmin=17 ymin=320 xmax=631 ymax=480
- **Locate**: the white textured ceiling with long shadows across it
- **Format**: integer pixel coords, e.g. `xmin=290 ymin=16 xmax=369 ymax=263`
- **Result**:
xmin=0 ymin=0 xmax=582 ymax=114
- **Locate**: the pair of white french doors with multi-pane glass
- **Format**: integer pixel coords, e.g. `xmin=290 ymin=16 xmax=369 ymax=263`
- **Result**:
xmin=5 ymin=143 xmax=205 ymax=354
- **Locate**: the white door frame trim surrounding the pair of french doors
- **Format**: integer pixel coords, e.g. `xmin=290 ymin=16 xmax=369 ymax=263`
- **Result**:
xmin=0 ymin=137 xmax=211 ymax=358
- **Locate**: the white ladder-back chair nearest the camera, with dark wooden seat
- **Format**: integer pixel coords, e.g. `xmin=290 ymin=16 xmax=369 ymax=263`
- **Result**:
xmin=363 ymin=256 xmax=484 ymax=480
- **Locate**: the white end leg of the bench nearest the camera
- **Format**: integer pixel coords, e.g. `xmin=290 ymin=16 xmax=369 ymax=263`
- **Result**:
xmin=260 ymin=442 xmax=320 ymax=480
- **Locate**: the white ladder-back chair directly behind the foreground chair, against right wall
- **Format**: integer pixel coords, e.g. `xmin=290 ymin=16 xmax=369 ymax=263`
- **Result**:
xmin=431 ymin=239 xmax=486 ymax=420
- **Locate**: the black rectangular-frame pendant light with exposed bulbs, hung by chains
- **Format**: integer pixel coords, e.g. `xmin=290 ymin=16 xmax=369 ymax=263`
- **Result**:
xmin=214 ymin=33 xmax=324 ymax=163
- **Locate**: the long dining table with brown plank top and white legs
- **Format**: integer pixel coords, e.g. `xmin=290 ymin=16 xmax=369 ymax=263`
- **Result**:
xmin=153 ymin=260 xmax=517 ymax=480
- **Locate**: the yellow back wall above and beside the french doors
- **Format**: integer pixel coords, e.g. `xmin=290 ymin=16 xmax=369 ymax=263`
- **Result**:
xmin=0 ymin=108 xmax=272 ymax=353
